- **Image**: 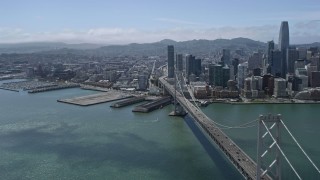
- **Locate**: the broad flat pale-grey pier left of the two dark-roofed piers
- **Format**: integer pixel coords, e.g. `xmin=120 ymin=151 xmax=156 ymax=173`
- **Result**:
xmin=57 ymin=91 xmax=132 ymax=106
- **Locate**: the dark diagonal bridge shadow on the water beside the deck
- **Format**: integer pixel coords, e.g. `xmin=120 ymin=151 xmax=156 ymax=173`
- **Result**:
xmin=184 ymin=115 xmax=243 ymax=179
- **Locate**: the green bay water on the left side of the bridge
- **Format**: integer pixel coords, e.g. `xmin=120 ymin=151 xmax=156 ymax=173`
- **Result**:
xmin=0 ymin=82 xmax=241 ymax=180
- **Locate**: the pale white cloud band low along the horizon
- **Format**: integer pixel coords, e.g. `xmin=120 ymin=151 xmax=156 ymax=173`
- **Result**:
xmin=0 ymin=22 xmax=320 ymax=44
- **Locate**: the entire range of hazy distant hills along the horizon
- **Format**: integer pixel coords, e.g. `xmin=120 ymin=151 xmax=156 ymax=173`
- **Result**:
xmin=0 ymin=37 xmax=320 ymax=56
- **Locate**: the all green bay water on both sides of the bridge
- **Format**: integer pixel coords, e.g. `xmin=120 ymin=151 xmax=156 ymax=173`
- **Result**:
xmin=0 ymin=81 xmax=320 ymax=179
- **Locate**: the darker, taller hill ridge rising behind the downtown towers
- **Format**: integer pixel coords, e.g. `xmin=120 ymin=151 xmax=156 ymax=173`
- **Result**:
xmin=91 ymin=38 xmax=266 ymax=55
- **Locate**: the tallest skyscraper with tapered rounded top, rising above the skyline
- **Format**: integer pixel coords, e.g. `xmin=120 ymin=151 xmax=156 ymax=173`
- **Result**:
xmin=278 ymin=21 xmax=289 ymax=78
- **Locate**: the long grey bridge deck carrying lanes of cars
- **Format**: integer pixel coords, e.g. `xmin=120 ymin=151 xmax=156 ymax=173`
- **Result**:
xmin=159 ymin=77 xmax=271 ymax=179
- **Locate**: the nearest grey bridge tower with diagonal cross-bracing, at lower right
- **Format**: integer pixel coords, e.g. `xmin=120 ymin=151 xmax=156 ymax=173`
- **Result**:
xmin=257 ymin=114 xmax=281 ymax=180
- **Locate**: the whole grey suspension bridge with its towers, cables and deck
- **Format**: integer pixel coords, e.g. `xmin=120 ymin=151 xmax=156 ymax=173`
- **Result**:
xmin=159 ymin=75 xmax=320 ymax=179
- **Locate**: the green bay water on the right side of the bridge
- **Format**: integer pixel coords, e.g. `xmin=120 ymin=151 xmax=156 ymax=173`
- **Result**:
xmin=202 ymin=104 xmax=320 ymax=179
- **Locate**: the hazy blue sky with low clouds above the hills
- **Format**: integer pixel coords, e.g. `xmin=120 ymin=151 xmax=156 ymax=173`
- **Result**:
xmin=0 ymin=0 xmax=320 ymax=44
